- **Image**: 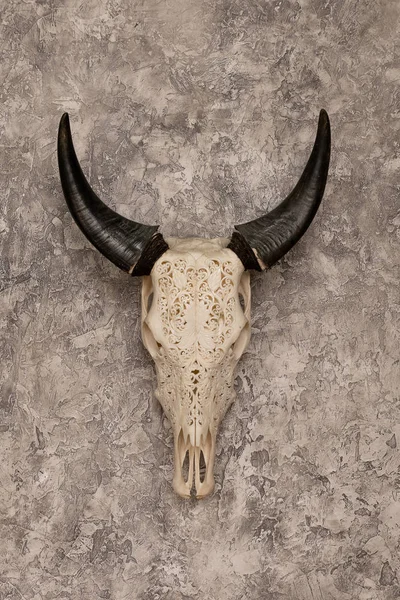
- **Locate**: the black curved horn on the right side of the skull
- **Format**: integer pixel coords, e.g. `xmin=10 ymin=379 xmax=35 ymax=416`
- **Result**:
xmin=228 ymin=110 xmax=331 ymax=271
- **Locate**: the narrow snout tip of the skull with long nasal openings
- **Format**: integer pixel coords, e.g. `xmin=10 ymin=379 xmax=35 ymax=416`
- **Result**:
xmin=173 ymin=429 xmax=215 ymax=499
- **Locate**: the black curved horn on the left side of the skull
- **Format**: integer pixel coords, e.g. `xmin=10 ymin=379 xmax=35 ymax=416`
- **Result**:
xmin=57 ymin=113 xmax=168 ymax=275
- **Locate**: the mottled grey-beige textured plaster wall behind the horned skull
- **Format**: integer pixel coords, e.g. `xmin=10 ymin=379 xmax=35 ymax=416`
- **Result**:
xmin=0 ymin=0 xmax=400 ymax=600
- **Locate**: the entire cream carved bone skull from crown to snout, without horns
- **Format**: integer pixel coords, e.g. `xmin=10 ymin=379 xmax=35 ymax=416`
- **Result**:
xmin=142 ymin=239 xmax=250 ymax=497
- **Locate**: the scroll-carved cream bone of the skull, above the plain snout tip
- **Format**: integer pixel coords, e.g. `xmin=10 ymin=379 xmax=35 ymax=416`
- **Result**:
xmin=144 ymin=240 xmax=250 ymax=446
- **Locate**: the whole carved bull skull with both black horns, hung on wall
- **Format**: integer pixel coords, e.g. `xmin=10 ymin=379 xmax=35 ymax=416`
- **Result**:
xmin=58 ymin=110 xmax=330 ymax=498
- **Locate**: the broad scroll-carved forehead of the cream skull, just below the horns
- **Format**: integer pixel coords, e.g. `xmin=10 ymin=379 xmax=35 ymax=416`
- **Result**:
xmin=146 ymin=238 xmax=247 ymax=356
